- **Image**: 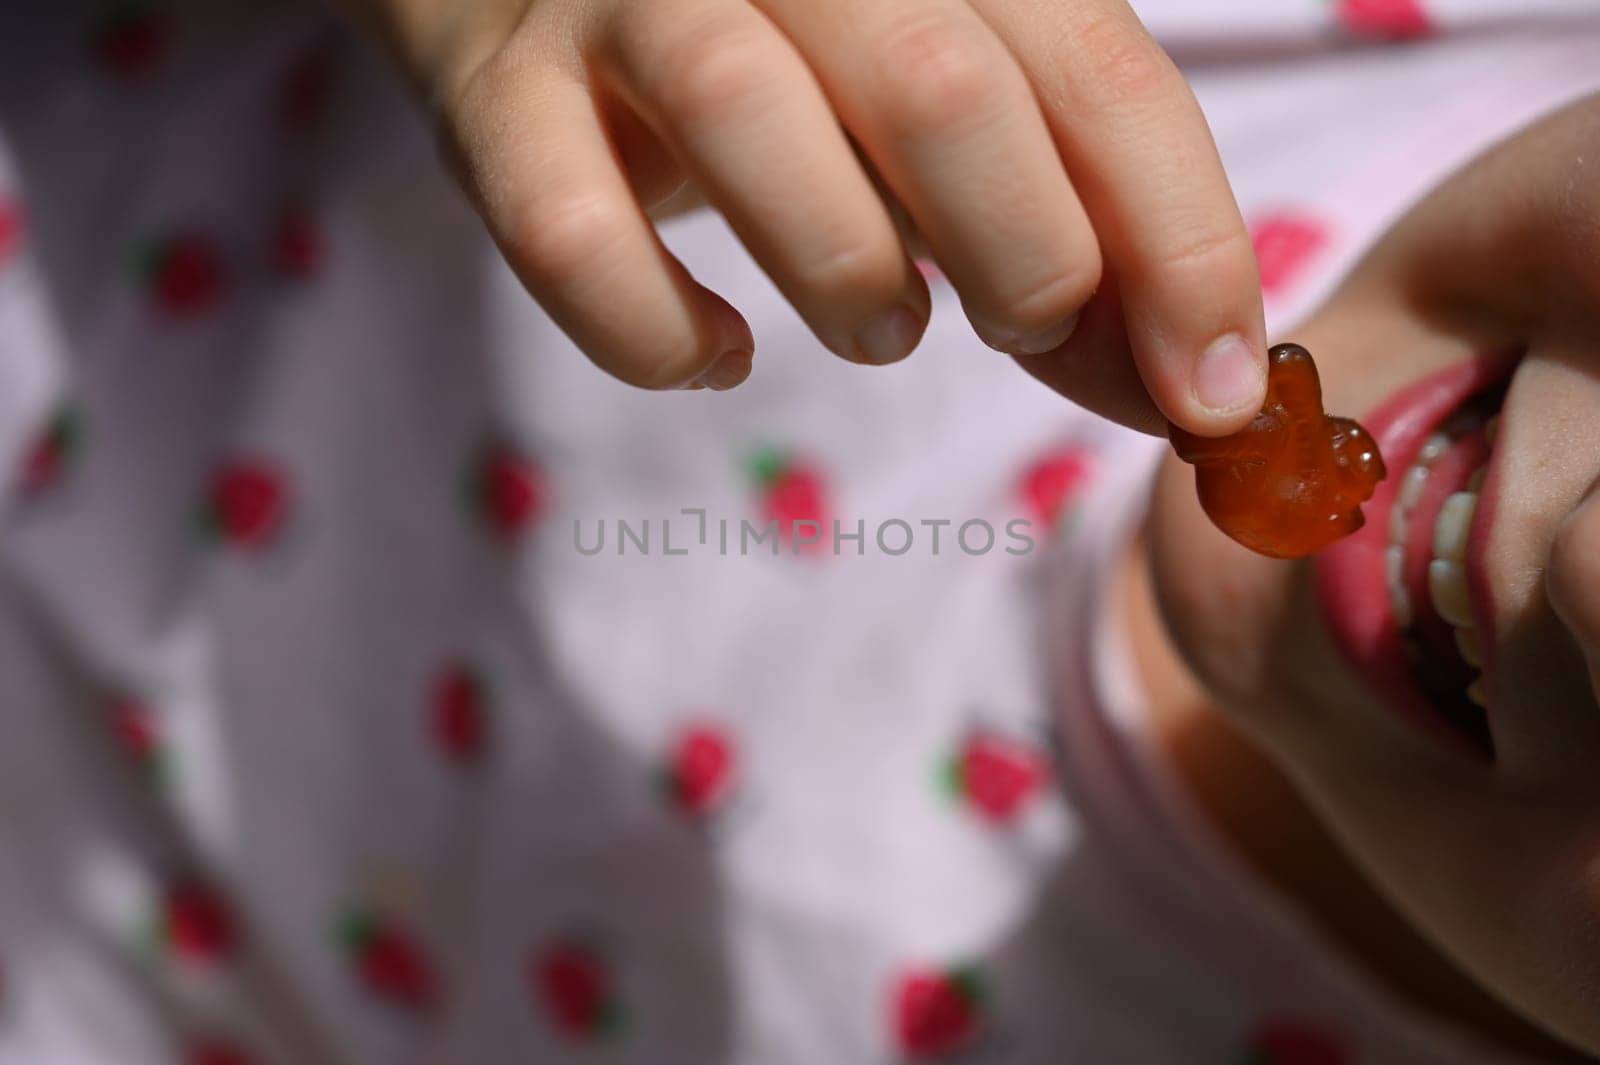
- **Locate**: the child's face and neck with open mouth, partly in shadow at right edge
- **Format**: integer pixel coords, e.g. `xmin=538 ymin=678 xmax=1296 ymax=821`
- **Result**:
xmin=1152 ymin=101 xmax=1600 ymax=1052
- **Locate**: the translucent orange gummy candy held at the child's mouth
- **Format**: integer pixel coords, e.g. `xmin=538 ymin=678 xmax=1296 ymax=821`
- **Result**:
xmin=1170 ymin=344 xmax=1387 ymax=558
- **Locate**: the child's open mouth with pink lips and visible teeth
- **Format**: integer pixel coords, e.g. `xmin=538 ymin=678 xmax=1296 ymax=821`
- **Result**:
xmin=1315 ymin=355 xmax=1520 ymax=758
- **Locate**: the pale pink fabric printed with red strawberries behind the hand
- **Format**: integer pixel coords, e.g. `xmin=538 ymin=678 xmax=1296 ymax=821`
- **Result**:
xmin=0 ymin=0 xmax=1600 ymax=1065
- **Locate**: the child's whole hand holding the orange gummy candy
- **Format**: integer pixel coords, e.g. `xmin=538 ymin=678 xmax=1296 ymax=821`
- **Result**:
xmin=334 ymin=0 xmax=1266 ymax=435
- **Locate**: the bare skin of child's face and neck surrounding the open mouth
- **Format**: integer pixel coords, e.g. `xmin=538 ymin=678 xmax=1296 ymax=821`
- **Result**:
xmin=1145 ymin=98 xmax=1600 ymax=1060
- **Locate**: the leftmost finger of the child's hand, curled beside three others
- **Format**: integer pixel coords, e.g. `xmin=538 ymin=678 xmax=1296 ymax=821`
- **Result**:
xmin=448 ymin=53 xmax=755 ymax=389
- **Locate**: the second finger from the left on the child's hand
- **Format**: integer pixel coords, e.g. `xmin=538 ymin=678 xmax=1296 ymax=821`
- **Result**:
xmin=606 ymin=0 xmax=930 ymax=363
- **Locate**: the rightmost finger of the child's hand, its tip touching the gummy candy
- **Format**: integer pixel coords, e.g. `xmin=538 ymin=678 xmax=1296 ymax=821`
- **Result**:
xmin=974 ymin=0 xmax=1266 ymax=435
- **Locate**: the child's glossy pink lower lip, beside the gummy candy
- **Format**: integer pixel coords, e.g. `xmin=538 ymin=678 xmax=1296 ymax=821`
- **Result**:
xmin=1314 ymin=355 xmax=1517 ymax=756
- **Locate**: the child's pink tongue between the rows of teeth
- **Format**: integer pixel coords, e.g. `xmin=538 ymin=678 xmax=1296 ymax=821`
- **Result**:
xmin=1403 ymin=429 xmax=1490 ymax=692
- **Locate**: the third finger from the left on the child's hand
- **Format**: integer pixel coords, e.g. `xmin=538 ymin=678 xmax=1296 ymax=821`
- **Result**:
xmin=755 ymin=0 xmax=1101 ymax=352
